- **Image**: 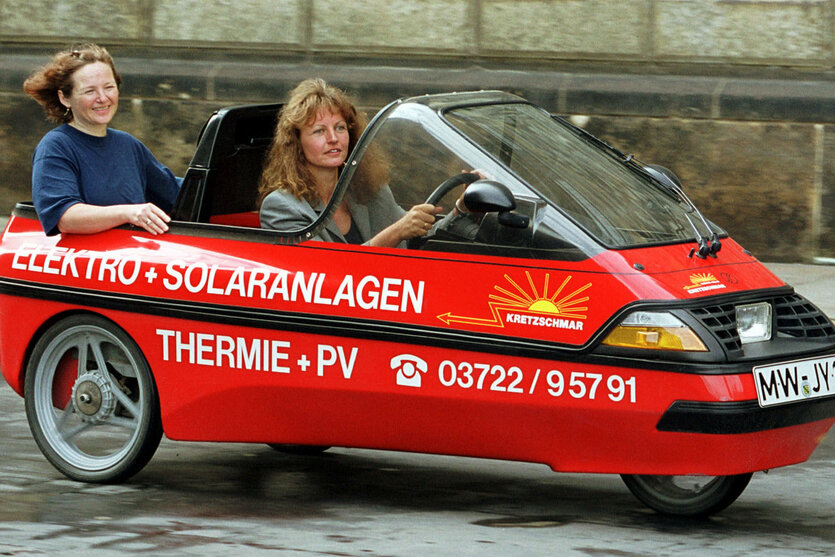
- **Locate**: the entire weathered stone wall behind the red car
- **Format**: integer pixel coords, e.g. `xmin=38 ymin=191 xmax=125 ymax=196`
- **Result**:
xmin=0 ymin=0 xmax=835 ymax=261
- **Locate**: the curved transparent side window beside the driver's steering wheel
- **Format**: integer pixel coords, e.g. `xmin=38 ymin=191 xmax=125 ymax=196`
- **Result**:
xmin=346 ymin=103 xmax=602 ymax=260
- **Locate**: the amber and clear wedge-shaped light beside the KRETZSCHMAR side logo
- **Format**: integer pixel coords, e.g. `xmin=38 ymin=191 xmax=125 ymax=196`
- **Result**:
xmin=603 ymin=311 xmax=707 ymax=352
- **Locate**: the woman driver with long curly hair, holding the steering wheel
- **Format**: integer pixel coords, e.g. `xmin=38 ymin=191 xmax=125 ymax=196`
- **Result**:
xmin=259 ymin=79 xmax=441 ymax=247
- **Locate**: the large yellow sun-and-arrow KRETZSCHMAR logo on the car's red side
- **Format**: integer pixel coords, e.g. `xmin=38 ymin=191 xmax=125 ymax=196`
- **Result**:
xmin=438 ymin=271 xmax=591 ymax=331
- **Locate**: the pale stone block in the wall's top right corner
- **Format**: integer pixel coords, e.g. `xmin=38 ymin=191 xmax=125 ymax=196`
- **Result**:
xmin=653 ymin=0 xmax=832 ymax=63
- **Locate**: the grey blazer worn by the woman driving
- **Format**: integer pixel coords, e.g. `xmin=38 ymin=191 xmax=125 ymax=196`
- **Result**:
xmin=260 ymin=186 xmax=406 ymax=247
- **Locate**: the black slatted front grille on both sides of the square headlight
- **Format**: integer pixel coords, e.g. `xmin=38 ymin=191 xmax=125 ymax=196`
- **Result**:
xmin=691 ymin=294 xmax=835 ymax=354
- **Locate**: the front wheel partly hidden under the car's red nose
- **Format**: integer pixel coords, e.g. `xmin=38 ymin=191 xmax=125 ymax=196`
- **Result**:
xmin=621 ymin=474 xmax=751 ymax=517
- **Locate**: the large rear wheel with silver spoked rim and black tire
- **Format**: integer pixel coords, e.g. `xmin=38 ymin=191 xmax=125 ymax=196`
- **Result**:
xmin=24 ymin=315 xmax=162 ymax=483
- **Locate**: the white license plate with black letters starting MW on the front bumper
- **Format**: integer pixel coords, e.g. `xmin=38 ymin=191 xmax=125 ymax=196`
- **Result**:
xmin=754 ymin=355 xmax=835 ymax=406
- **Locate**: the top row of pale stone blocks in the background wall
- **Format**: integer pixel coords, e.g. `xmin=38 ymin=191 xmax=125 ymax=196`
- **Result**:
xmin=0 ymin=0 xmax=835 ymax=68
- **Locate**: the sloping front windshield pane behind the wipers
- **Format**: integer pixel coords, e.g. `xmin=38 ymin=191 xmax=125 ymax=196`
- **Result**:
xmin=445 ymin=103 xmax=720 ymax=248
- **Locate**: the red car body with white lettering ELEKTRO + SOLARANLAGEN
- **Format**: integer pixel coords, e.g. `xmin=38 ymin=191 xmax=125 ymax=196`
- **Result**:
xmin=0 ymin=211 xmax=835 ymax=475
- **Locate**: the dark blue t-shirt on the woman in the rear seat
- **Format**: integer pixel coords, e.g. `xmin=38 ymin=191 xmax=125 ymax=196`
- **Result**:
xmin=32 ymin=124 xmax=182 ymax=236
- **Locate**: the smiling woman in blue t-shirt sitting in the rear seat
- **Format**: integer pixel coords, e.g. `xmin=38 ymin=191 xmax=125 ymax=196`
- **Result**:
xmin=23 ymin=44 xmax=181 ymax=235
